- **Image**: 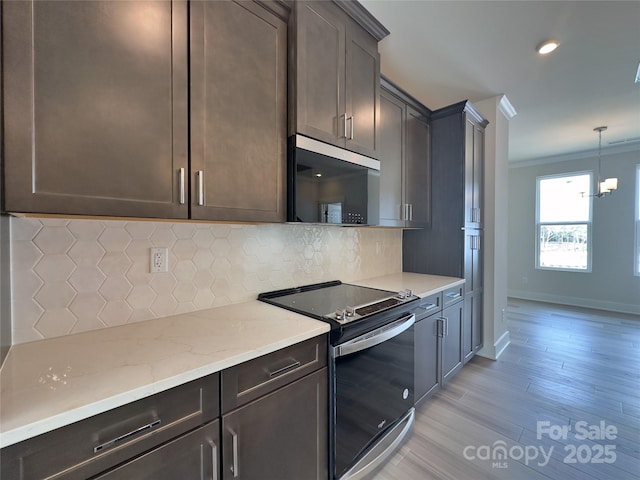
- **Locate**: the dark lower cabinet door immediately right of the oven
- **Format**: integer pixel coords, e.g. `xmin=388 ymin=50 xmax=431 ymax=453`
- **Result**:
xmin=414 ymin=313 xmax=441 ymax=404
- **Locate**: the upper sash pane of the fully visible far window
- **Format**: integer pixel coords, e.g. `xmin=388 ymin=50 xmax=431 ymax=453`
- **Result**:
xmin=539 ymin=174 xmax=591 ymax=222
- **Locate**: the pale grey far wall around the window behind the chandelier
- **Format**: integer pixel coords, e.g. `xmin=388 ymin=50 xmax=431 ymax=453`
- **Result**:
xmin=508 ymin=146 xmax=640 ymax=314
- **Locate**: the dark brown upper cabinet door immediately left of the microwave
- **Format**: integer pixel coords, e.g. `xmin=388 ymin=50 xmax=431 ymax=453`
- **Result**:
xmin=190 ymin=1 xmax=287 ymax=222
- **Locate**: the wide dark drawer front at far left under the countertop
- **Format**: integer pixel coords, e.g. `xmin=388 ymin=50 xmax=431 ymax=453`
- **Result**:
xmin=0 ymin=373 xmax=220 ymax=480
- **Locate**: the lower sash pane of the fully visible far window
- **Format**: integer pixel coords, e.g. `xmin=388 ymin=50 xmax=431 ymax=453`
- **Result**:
xmin=538 ymin=224 xmax=589 ymax=270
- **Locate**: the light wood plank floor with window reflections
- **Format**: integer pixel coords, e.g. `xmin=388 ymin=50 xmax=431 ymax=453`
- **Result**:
xmin=375 ymin=300 xmax=640 ymax=480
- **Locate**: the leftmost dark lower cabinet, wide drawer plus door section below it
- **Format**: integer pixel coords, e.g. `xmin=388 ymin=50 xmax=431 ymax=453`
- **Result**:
xmin=0 ymin=373 xmax=220 ymax=480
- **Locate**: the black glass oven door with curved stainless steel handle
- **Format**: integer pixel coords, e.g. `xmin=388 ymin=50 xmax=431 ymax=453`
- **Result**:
xmin=332 ymin=314 xmax=415 ymax=479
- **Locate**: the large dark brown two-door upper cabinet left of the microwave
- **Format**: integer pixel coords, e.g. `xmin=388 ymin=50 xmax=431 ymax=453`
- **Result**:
xmin=2 ymin=0 xmax=289 ymax=222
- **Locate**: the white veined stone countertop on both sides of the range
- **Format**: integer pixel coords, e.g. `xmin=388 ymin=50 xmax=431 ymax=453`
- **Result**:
xmin=0 ymin=273 xmax=464 ymax=447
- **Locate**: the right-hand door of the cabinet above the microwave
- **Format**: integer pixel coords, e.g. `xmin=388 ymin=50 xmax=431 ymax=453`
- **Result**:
xmin=345 ymin=20 xmax=380 ymax=158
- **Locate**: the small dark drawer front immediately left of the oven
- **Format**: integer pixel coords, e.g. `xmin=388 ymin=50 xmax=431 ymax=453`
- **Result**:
xmin=221 ymin=335 xmax=327 ymax=413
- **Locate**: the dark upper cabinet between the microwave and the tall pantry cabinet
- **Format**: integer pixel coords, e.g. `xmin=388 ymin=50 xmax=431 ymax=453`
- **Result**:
xmin=379 ymin=77 xmax=431 ymax=228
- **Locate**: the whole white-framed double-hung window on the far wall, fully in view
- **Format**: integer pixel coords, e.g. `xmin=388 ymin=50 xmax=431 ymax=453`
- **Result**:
xmin=536 ymin=172 xmax=592 ymax=272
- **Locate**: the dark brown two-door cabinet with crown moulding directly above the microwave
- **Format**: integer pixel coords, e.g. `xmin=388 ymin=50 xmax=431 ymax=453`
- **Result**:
xmin=289 ymin=1 xmax=389 ymax=158
